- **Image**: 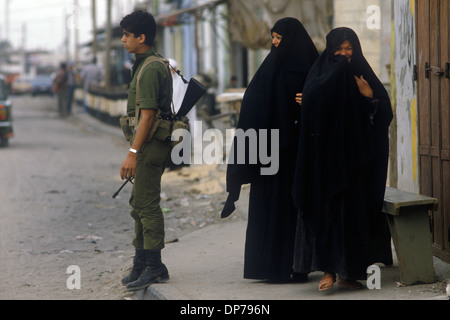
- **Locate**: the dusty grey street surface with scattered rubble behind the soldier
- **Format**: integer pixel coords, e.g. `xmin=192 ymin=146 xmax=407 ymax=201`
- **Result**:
xmin=0 ymin=96 xmax=232 ymax=300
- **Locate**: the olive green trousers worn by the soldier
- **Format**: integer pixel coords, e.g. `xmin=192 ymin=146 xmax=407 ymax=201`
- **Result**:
xmin=129 ymin=130 xmax=171 ymax=250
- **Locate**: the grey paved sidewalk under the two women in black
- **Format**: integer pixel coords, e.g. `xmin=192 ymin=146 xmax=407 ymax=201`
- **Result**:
xmin=136 ymin=219 xmax=450 ymax=300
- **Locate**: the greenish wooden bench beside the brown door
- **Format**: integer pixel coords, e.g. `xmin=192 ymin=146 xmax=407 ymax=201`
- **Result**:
xmin=383 ymin=187 xmax=438 ymax=286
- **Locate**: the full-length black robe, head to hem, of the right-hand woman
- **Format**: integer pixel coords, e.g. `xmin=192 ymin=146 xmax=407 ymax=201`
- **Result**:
xmin=293 ymin=28 xmax=393 ymax=280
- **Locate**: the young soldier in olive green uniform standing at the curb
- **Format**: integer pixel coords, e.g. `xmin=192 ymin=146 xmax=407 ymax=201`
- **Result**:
xmin=120 ymin=11 xmax=173 ymax=291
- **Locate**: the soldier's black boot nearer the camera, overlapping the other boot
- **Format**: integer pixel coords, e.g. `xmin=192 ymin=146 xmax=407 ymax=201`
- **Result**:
xmin=127 ymin=250 xmax=169 ymax=291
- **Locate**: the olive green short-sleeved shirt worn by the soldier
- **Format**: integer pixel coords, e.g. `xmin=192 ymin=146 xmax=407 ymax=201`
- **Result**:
xmin=127 ymin=48 xmax=173 ymax=117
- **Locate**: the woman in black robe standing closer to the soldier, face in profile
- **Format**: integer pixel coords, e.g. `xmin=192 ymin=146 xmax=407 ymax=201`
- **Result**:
xmin=222 ymin=18 xmax=318 ymax=280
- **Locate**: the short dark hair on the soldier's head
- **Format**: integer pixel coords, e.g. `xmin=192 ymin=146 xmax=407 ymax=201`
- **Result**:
xmin=120 ymin=10 xmax=156 ymax=46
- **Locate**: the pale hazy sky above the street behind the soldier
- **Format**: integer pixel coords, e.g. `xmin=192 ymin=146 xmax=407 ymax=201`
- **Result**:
xmin=0 ymin=0 xmax=138 ymax=51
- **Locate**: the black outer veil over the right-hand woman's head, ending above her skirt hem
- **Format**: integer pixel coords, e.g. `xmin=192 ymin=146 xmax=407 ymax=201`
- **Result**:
xmin=293 ymin=28 xmax=393 ymax=229
